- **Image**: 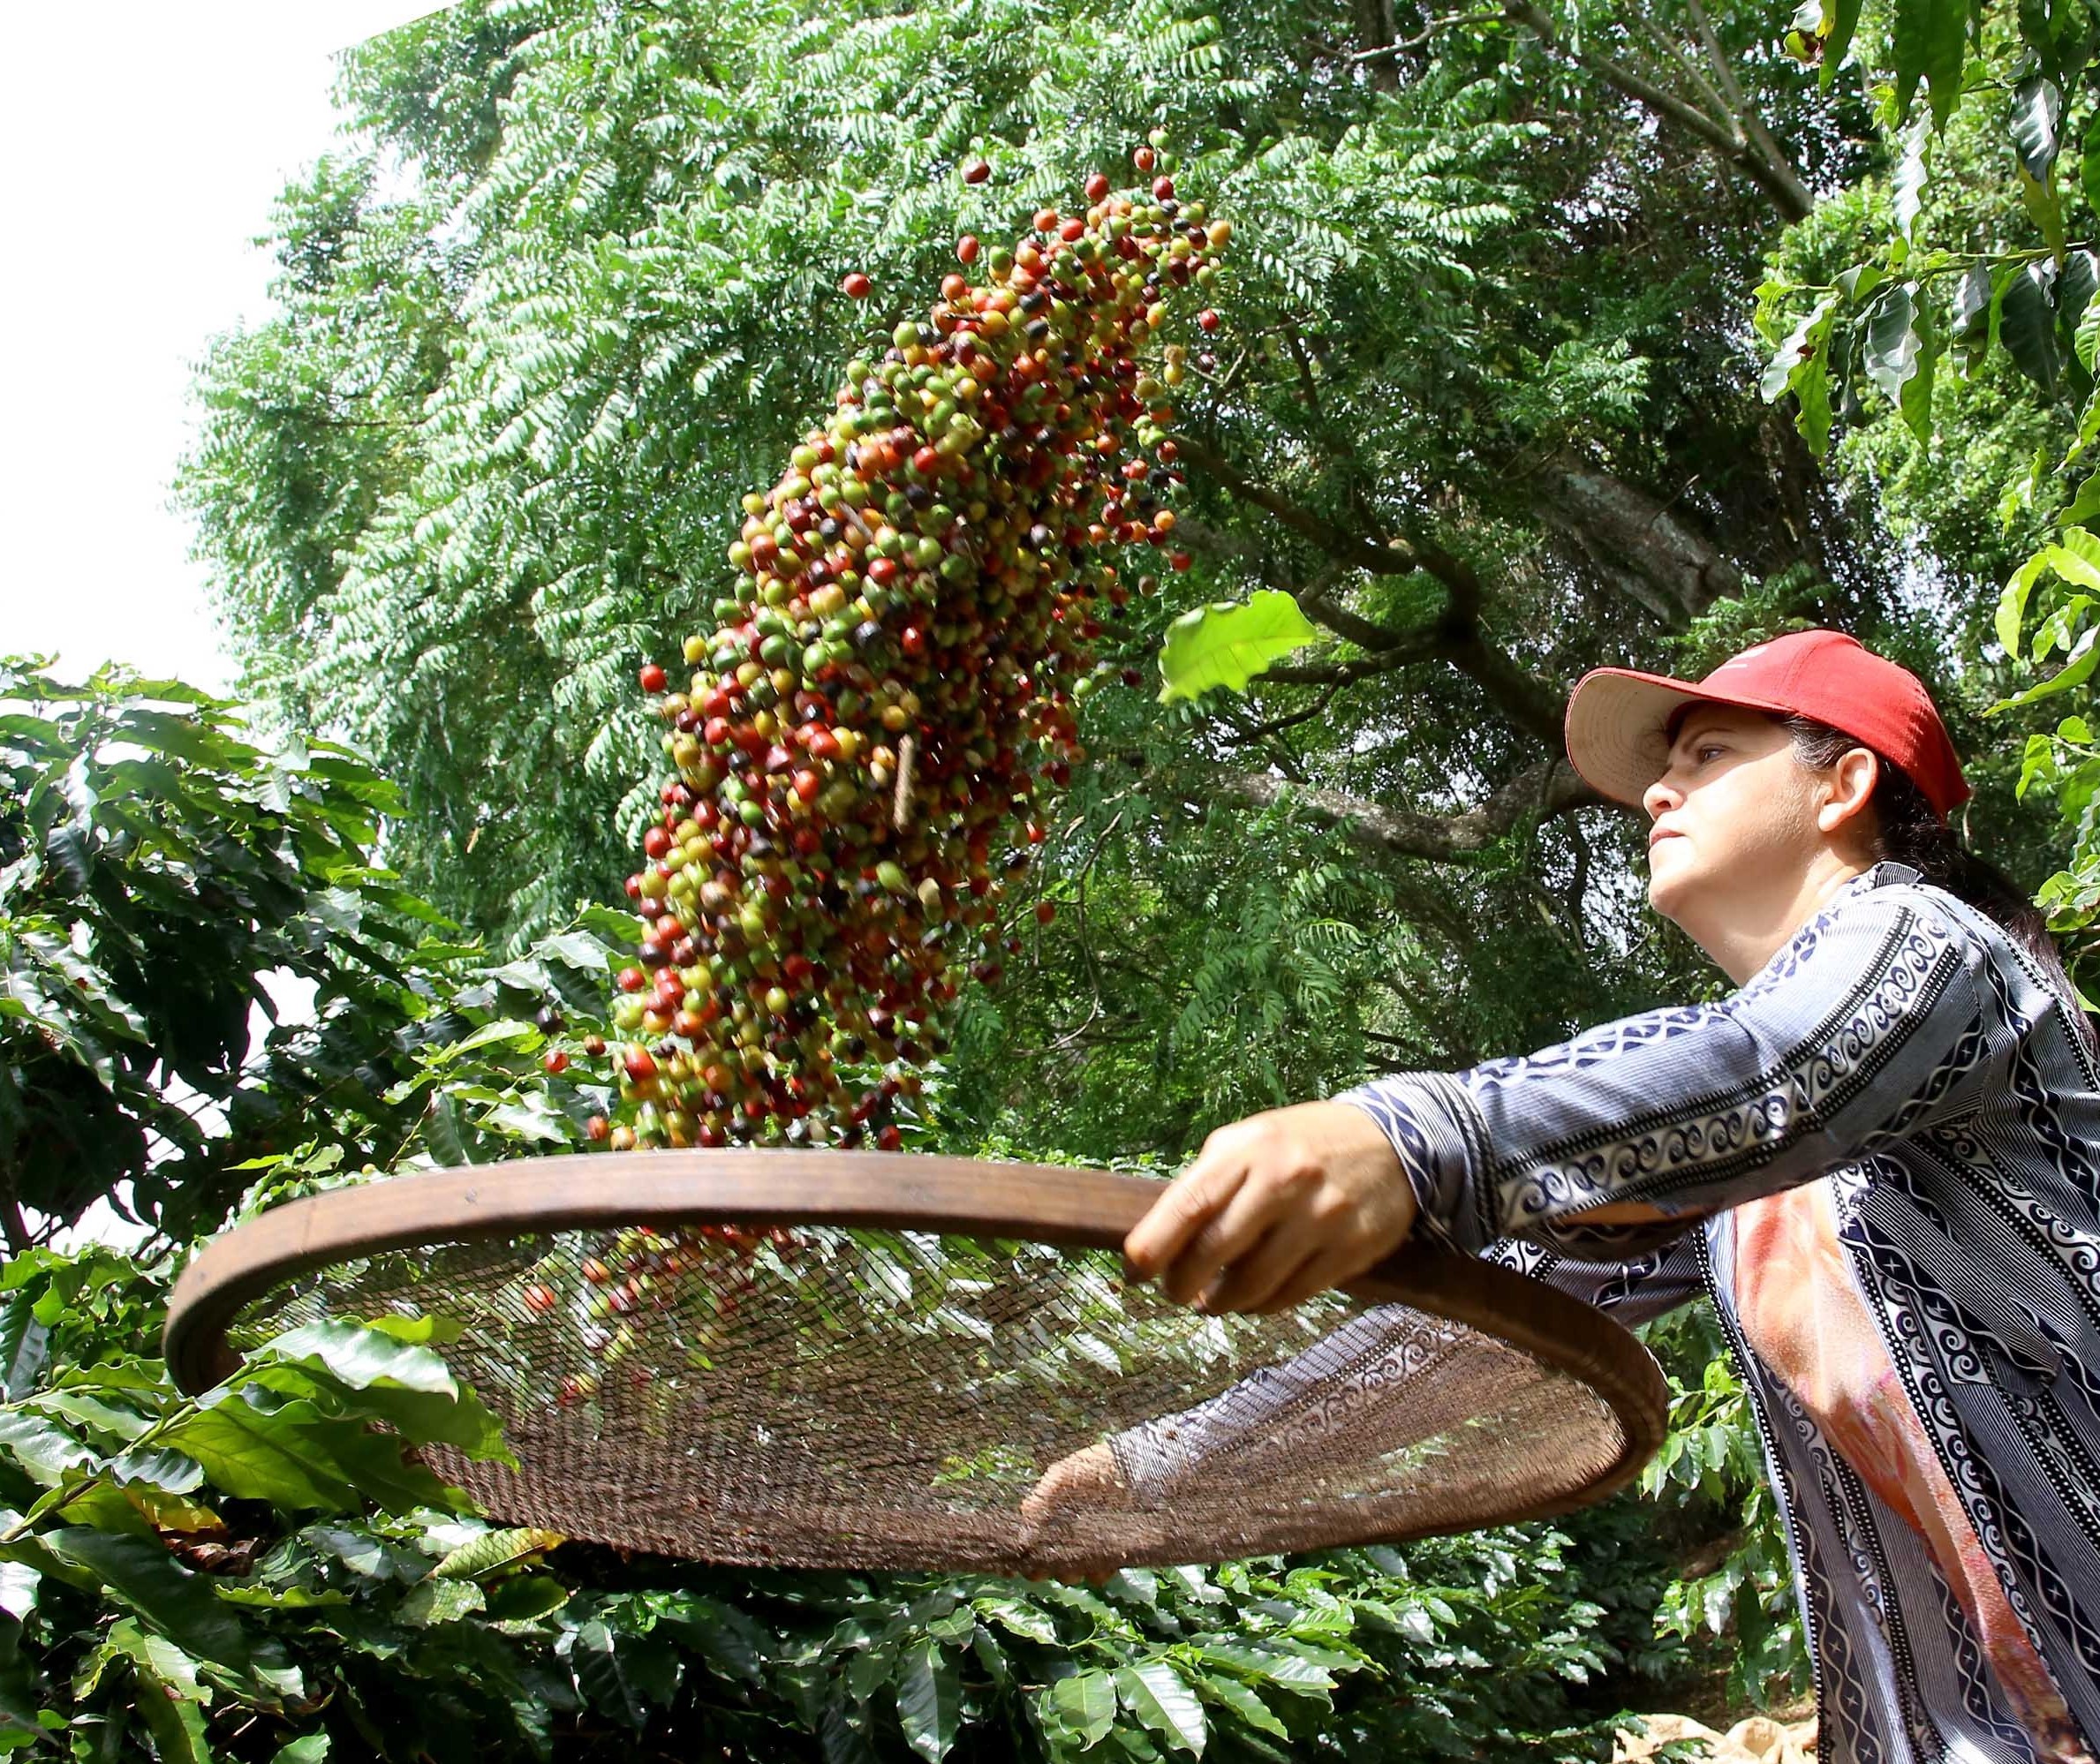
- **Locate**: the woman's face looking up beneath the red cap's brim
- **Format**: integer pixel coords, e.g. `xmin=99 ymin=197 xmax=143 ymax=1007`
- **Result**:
xmin=1643 ymin=704 xmax=1827 ymax=923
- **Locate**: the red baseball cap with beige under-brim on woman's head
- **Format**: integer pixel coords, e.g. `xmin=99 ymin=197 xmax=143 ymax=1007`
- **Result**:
xmin=1567 ymin=630 xmax=1970 ymax=821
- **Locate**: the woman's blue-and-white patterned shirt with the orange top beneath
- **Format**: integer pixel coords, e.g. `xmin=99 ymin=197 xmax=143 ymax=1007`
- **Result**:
xmin=1111 ymin=863 xmax=2100 ymax=1764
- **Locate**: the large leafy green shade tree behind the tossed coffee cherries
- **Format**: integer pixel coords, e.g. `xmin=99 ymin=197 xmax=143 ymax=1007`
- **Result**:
xmin=185 ymin=0 xmax=2082 ymax=1155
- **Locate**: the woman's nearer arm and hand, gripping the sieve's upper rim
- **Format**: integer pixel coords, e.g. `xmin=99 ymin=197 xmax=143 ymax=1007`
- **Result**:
xmin=1123 ymin=884 xmax=1987 ymax=1310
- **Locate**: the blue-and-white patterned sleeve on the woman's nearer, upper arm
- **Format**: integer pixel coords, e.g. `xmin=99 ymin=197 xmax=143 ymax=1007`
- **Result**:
xmin=1338 ymin=882 xmax=1987 ymax=1260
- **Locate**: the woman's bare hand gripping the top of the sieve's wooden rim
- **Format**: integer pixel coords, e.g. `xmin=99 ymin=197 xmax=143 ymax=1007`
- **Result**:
xmin=1123 ymin=1103 xmax=1416 ymax=1310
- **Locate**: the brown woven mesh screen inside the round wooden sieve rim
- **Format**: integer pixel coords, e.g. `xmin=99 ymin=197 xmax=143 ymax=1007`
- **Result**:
xmin=229 ymin=1226 xmax=1626 ymax=1575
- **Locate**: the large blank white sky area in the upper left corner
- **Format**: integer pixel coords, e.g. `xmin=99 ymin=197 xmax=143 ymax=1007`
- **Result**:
xmin=0 ymin=0 xmax=462 ymax=691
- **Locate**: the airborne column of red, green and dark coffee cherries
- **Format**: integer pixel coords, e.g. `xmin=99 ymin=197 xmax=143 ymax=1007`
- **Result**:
xmin=593 ymin=143 xmax=1231 ymax=1149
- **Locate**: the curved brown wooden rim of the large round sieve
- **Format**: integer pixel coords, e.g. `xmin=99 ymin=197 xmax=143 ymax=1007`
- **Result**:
xmin=162 ymin=1150 xmax=1670 ymax=1525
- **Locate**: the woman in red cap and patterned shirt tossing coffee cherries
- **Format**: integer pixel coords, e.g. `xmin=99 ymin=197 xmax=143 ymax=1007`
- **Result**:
xmin=1031 ymin=630 xmax=2100 ymax=1764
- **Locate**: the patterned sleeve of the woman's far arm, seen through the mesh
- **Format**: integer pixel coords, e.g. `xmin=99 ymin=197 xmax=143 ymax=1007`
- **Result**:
xmin=1109 ymin=1226 xmax=1701 ymax=1504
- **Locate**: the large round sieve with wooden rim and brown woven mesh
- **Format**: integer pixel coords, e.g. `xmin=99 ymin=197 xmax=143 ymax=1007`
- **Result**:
xmin=166 ymin=1150 xmax=1666 ymax=1575
